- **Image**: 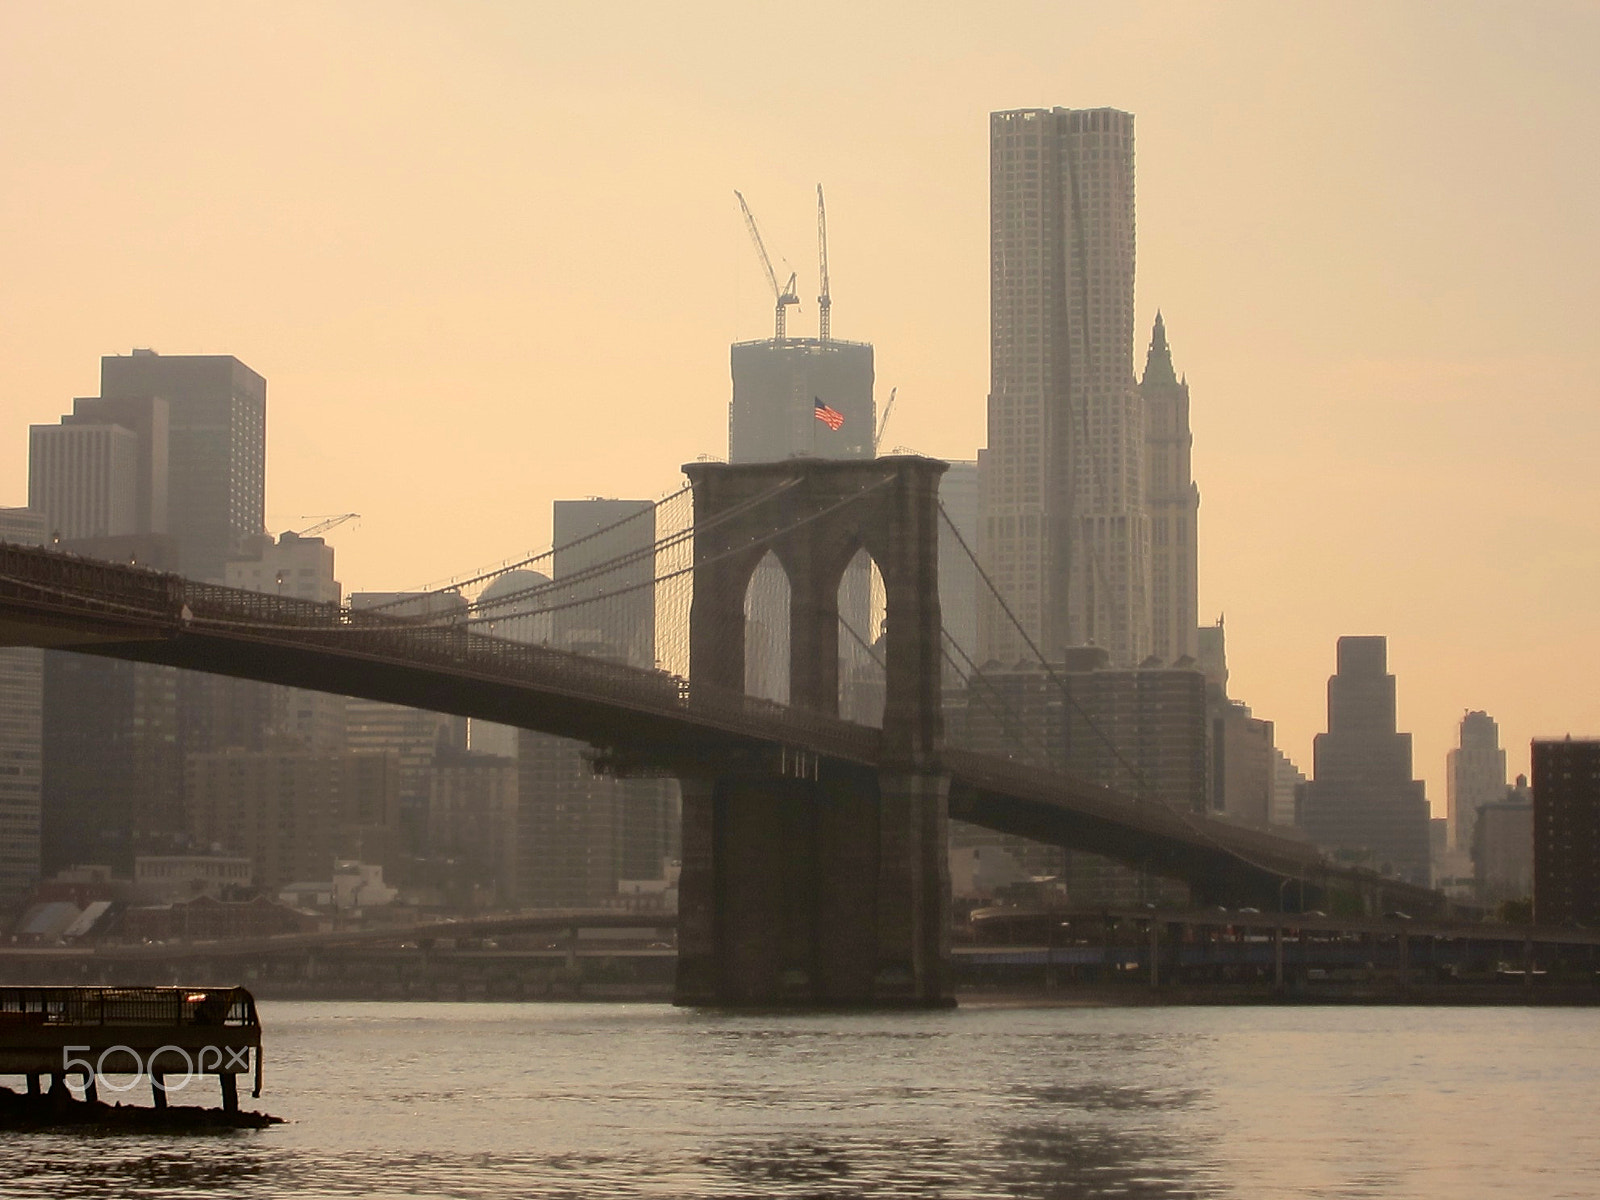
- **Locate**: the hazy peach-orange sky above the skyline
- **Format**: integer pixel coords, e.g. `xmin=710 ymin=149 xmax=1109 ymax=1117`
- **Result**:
xmin=0 ymin=0 xmax=1600 ymax=814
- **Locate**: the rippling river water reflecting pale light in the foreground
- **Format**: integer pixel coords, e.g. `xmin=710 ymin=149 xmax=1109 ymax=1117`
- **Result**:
xmin=0 ymin=1003 xmax=1600 ymax=1200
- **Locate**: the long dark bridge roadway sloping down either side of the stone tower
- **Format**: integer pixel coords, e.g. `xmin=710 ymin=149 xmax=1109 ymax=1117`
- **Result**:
xmin=0 ymin=544 xmax=1440 ymax=914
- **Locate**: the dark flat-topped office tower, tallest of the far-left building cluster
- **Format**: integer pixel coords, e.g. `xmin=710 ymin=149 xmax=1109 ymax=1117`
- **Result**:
xmin=99 ymin=350 xmax=267 ymax=582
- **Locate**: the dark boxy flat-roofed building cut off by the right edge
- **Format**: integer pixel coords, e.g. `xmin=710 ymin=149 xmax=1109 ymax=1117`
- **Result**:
xmin=1533 ymin=734 xmax=1600 ymax=926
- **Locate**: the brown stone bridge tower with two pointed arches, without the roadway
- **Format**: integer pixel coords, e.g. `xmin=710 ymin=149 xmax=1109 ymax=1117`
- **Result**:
xmin=677 ymin=456 xmax=950 ymax=1005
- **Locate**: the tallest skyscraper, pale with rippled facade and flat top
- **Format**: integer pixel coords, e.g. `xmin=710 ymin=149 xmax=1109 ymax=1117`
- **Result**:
xmin=979 ymin=109 xmax=1150 ymax=666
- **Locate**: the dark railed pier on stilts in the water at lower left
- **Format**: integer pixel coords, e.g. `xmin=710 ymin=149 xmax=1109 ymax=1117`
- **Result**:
xmin=0 ymin=987 xmax=261 ymax=1114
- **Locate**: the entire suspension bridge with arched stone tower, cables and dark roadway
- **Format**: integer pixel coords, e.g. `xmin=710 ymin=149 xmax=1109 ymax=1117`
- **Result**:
xmin=0 ymin=456 xmax=1438 ymax=1005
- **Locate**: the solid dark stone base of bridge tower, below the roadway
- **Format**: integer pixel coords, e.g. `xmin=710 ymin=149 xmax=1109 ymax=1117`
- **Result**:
xmin=675 ymin=768 xmax=952 ymax=1008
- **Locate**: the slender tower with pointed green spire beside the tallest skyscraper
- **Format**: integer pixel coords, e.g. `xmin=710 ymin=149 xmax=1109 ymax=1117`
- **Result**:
xmin=1139 ymin=314 xmax=1200 ymax=662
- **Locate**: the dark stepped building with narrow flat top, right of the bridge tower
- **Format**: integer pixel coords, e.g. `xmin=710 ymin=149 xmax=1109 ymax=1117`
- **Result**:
xmin=1301 ymin=637 xmax=1430 ymax=886
